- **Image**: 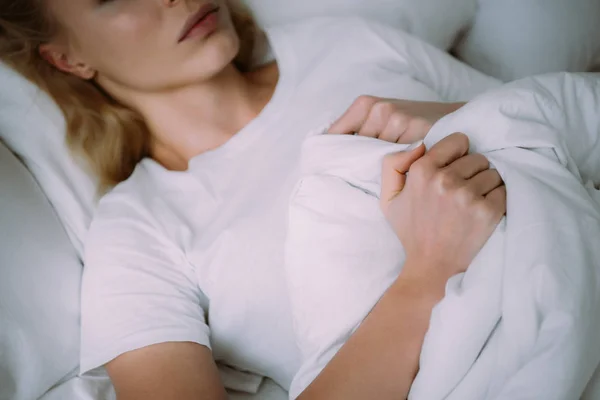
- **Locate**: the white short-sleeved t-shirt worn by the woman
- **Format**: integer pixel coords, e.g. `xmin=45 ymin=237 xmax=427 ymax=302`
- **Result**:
xmin=81 ymin=18 xmax=499 ymax=394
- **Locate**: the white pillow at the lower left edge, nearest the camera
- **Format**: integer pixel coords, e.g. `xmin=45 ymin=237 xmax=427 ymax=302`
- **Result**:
xmin=0 ymin=143 xmax=82 ymax=400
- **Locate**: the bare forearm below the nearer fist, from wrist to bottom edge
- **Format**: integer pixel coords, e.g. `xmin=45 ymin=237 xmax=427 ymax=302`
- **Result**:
xmin=298 ymin=261 xmax=452 ymax=400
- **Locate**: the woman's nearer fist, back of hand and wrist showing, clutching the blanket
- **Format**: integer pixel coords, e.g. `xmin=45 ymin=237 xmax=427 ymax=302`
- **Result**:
xmin=381 ymin=133 xmax=506 ymax=289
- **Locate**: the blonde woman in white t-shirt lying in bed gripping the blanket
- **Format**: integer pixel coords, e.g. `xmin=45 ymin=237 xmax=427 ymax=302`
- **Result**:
xmin=0 ymin=0 xmax=505 ymax=399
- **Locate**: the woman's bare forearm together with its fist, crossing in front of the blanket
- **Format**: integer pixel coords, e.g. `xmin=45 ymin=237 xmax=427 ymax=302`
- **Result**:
xmin=299 ymin=134 xmax=506 ymax=400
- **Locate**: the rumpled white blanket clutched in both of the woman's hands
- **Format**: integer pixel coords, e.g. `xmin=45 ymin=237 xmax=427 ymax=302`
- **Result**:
xmin=286 ymin=74 xmax=600 ymax=400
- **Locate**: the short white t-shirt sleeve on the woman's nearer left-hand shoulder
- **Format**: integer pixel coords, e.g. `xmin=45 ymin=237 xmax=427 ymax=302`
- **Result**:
xmin=80 ymin=189 xmax=210 ymax=374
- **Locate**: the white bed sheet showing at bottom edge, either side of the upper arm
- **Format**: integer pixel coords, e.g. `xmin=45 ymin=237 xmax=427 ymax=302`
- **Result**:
xmin=39 ymin=375 xmax=288 ymax=400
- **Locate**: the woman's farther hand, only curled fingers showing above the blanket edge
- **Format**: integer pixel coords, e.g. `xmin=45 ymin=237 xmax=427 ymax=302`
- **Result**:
xmin=329 ymin=96 xmax=464 ymax=144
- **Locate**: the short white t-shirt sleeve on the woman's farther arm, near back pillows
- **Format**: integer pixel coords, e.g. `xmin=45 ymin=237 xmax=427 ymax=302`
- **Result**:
xmin=368 ymin=23 xmax=502 ymax=102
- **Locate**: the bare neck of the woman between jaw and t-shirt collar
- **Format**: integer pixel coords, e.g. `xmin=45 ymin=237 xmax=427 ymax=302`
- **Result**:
xmin=103 ymin=65 xmax=275 ymax=170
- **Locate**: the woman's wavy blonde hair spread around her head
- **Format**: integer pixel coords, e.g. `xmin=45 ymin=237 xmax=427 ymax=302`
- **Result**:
xmin=0 ymin=0 xmax=257 ymax=189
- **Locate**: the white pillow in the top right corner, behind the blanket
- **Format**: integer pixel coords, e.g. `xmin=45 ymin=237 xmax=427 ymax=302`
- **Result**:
xmin=456 ymin=0 xmax=600 ymax=81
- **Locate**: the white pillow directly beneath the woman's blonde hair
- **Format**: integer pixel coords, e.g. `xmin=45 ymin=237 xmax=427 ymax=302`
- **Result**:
xmin=0 ymin=63 xmax=97 ymax=257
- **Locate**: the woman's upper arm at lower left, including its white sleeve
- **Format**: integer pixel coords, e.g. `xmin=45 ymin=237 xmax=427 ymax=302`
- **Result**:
xmin=80 ymin=190 xmax=227 ymax=400
